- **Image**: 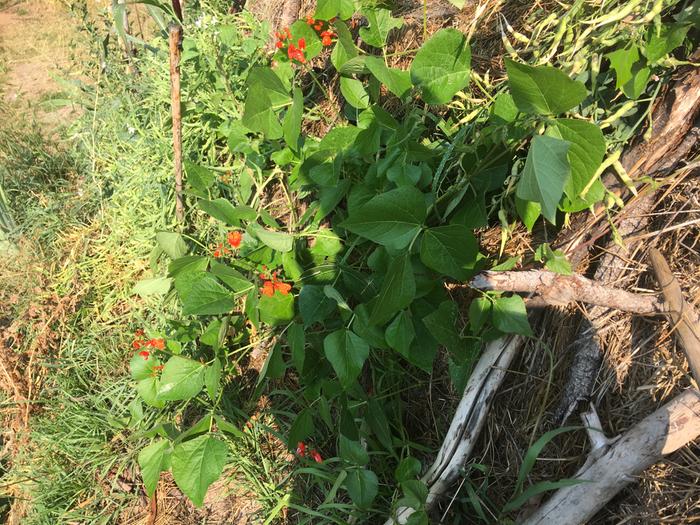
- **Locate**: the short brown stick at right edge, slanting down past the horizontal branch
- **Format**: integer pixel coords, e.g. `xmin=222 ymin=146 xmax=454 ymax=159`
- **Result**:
xmin=649 ymin=248 xmax=700 ymax=385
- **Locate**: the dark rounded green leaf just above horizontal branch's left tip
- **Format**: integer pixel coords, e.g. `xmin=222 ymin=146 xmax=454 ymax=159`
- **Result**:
xmin=420 ymin=224 xmax=479 ymax=281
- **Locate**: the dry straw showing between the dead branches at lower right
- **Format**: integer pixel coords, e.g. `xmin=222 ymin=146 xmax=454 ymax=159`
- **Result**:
xmin=454 ymin=166 xmax=700 ymax=523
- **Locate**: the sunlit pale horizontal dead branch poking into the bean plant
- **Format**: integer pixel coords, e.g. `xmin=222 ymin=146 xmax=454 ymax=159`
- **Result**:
xmin=469 ymin=270 xmax=668 ymax=315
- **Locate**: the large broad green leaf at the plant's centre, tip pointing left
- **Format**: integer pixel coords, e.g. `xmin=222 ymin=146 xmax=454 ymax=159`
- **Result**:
xmin=341 ymin=187 xmax=428 ymax=249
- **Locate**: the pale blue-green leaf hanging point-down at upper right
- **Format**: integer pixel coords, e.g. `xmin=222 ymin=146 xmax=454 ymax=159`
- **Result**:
xmin=516 ymin=135 xmax=570 ymax=224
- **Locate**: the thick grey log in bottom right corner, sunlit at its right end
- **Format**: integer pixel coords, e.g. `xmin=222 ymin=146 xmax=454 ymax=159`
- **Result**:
xmin=521 ymin=390 xmax=700 ymax=525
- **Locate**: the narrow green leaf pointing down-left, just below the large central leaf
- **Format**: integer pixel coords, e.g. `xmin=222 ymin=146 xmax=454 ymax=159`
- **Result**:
xmin=370 ymin=253 xmax=416 ymax=325
